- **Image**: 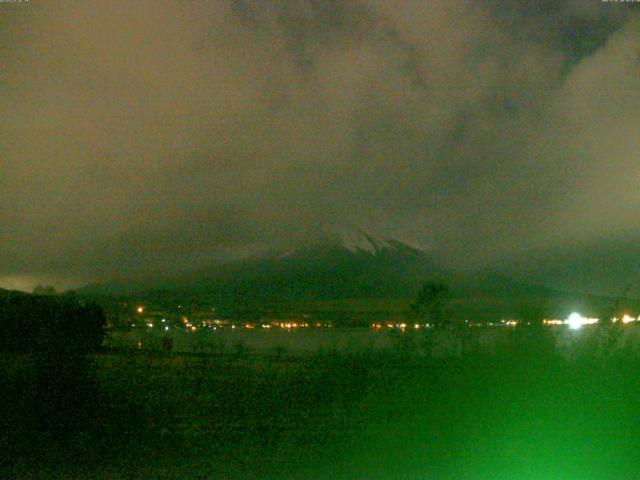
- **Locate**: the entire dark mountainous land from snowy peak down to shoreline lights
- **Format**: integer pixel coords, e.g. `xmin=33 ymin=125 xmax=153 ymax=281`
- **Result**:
xmin=78 ymin=229 xmax=635 ymax=320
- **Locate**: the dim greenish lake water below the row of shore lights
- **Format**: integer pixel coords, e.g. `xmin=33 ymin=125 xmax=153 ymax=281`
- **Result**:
xmin=105 ymin=325 xmax=640 ymax=357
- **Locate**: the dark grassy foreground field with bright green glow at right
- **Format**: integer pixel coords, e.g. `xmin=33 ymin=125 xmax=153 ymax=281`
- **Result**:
xmin=0 ymin=328 xmax=640 ymax=480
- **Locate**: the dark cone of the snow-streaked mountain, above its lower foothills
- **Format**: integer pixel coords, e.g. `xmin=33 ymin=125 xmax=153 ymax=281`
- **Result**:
xmin=78 ymin=229 xmax=446 ymax=300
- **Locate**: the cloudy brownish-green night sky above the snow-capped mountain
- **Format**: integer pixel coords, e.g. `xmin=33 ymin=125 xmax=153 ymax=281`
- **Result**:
xmin=0 ymin=0 xmax=640 ymax=288
